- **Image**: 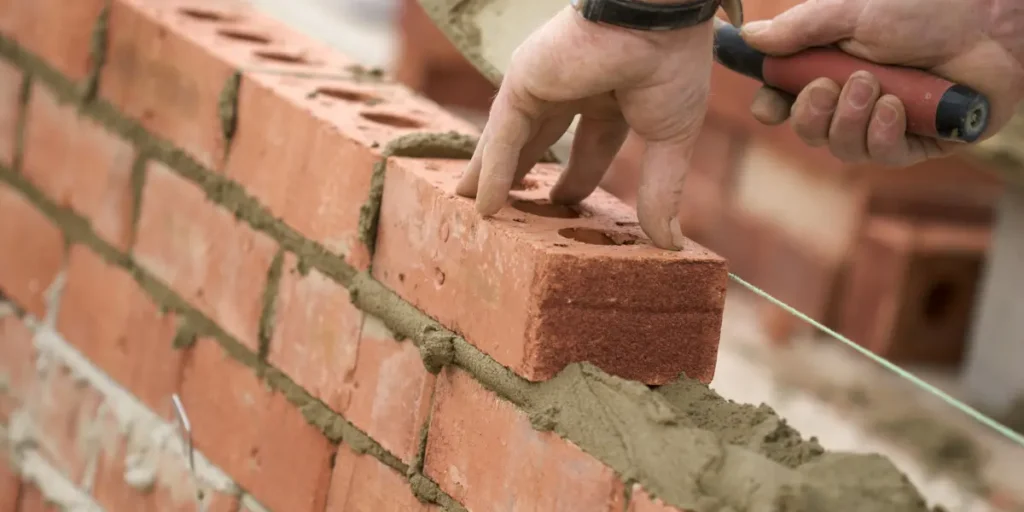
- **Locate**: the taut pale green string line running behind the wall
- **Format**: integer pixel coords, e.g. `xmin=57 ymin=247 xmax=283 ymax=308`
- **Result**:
xmin=729 ymin=272 xmax=1024 ymax=446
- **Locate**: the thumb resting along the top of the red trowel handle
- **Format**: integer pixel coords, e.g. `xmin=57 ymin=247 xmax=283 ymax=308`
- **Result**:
xmin=740 ymin=0 xmax=863 ymax=55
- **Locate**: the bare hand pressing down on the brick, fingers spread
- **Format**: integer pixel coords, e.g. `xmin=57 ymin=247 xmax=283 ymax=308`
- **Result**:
xmin=457 ymin=8 xmax=713 ymax=249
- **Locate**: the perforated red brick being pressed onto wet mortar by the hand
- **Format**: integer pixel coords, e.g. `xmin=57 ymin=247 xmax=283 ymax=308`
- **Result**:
xmin=373 ymin=158 xmax=727 ymax=384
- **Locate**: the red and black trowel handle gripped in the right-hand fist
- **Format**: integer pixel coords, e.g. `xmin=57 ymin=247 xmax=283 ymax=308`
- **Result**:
xmin=715 ymin=23 xmax=989 ymax=142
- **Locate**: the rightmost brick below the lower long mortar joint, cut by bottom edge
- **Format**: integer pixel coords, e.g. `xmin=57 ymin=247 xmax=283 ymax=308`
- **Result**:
xmin=327 ymin=444 xmax=441 ymax=512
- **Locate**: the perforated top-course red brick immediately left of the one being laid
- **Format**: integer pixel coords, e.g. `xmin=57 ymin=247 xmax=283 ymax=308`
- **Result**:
xmin=224 ymin=74 xmax=475 ymax=269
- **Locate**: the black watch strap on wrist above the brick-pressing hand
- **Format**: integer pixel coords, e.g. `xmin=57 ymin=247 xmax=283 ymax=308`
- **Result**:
xmin=572 ymin=0 xmax=722 ymax=31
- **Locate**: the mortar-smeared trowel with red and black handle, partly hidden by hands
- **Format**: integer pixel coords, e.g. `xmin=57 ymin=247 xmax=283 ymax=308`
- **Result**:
xmin=419 ymin=0 xmax=989 ymax=153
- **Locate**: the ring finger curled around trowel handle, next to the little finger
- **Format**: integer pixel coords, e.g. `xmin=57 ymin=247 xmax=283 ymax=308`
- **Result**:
xmin=828 ymin=71 xmax=881 ymax=162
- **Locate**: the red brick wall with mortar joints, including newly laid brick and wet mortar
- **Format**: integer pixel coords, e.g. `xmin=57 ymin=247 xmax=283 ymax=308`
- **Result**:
xmin=0 ymin=0 xmax=926 ymax=512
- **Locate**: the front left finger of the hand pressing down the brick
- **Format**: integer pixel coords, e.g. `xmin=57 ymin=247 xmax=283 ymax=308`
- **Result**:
xmin=476 ymin=92 xmax=534 ymax=216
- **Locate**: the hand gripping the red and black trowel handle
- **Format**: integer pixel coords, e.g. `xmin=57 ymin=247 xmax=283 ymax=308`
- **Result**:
xmin=741 ymin=0 xmax=1024 ymax=166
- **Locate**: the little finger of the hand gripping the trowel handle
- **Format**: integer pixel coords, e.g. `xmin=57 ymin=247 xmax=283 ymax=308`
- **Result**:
xmin=867 ymin=94 xmax=944 ymax=167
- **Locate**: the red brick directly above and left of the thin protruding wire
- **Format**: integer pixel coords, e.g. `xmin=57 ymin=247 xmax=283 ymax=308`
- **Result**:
xmin=57 ymin=246 xmax=181 ymax=418
